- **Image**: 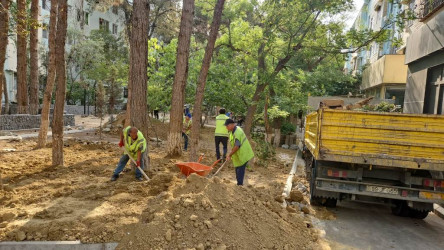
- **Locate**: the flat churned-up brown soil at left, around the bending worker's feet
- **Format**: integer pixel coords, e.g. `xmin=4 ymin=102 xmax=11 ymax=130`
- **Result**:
xmin=0 ymin=138 xmax=177 ymax=243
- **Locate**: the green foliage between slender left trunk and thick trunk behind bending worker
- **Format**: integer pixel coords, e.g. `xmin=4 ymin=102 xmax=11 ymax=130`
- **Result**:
xmin=67 ymin=30 xmax=129 ymax=108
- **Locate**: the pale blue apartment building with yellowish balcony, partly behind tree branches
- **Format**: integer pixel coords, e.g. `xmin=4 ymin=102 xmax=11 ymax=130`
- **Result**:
xmin=345 ymin=0 xmax=412 ymax=105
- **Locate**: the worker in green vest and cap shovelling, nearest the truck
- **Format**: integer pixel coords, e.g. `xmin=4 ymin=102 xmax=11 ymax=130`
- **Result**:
xmin=225 ymin=119 xmax=254 ymax=186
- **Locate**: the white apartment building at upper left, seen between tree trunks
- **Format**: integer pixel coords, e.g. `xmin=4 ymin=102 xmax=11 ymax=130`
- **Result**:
xmin=2 ymin=0 xmax=125 ymax=102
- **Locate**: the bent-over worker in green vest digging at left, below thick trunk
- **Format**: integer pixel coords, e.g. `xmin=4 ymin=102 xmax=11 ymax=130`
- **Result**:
xmin=111 ymin=126 xmax=146 ymax=181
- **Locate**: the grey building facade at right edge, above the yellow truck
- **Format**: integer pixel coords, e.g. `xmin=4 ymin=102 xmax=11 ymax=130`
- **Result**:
xmin=404 ymin=0 xmax=444 ymax=115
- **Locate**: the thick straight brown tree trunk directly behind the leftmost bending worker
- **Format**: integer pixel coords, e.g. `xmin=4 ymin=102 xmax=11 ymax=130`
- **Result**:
xmin=127 ymin=0 xmax=149 ymax=140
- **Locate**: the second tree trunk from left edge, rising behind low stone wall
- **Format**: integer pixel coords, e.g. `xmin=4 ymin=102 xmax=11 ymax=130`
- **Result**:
xmin=17 ymin=0 xmax=28 ymax=114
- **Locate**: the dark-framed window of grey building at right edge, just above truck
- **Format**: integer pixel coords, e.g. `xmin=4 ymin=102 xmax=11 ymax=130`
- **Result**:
xmin=423 ymin=64 xmax=444 ymax=115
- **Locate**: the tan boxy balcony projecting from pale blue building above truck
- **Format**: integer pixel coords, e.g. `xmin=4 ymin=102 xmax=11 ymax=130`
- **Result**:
xmin=361 ymin=55 xmax=407 ymax=90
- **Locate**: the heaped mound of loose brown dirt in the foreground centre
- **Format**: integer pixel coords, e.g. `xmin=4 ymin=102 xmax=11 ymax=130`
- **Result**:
xmin=118 ymin=174 xmax=318 ymax=249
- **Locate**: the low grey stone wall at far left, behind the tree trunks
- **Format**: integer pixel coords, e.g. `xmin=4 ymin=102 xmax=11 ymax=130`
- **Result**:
xmin=0 ymin=114 xmax=75 ymax=130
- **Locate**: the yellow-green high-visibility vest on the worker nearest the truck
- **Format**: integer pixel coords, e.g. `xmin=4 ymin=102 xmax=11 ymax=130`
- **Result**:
xmin=230 ymin=127 xmax=254 ymax=167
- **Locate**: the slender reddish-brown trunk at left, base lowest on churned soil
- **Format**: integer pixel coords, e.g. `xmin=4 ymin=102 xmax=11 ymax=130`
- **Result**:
xmin=52 ymin=0 xmax=68 ymax=166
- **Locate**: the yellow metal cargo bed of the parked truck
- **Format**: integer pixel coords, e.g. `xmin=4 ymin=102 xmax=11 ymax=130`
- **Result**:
xmin=305 ymin=109 xmax=444 ymax=171
